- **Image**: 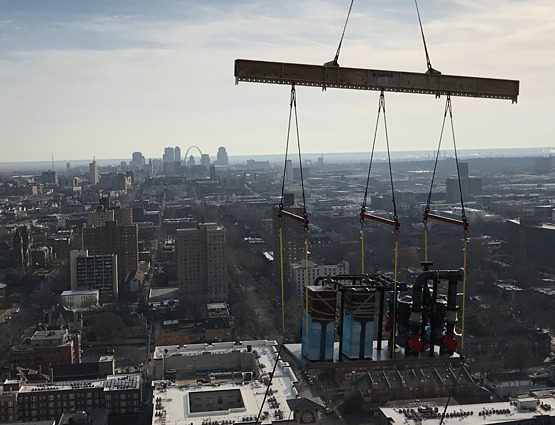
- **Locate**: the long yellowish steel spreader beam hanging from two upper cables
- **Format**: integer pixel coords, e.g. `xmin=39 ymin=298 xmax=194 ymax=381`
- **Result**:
xmin=235 ymin=59 xmax=519 ymax=103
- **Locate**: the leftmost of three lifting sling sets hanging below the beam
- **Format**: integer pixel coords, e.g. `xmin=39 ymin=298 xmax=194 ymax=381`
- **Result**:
xmin=278 ymin=83 xmax=308 ymax=347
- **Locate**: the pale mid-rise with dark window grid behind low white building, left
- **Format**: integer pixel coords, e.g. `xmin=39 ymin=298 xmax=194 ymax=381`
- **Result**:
xmin=70 ymin=250 xmax=119 ymax=304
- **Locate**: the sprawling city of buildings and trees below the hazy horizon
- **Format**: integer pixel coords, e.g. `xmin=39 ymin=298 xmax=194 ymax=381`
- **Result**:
xmin=0 ymin=147 xmax=555 ymax=424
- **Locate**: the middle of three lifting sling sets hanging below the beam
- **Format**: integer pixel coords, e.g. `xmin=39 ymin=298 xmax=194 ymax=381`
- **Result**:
xmin=360 ymin=90 xmax=400 ymax=358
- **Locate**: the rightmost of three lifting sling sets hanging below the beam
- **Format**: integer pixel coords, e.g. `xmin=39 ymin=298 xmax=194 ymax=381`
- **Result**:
xmin=423 ymin=95 xmax=469 ymax=349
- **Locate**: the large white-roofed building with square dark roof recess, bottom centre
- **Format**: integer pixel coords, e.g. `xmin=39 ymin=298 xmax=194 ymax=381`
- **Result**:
xmin=152 ymin=341 xmax=302 ymax=425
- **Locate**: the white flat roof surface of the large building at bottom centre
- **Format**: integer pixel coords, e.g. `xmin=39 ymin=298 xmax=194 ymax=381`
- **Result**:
xmin=152 ymin=341 xmax=297 ymax=425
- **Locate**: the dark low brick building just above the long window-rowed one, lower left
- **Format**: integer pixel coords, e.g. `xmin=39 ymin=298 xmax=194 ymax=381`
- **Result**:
xmin=10 ymin=329 xmax=81 ymax=370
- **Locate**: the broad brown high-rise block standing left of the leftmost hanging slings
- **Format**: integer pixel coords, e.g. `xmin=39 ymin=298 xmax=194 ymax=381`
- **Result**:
xmin=179 ymin=223 xmax=228 ymax=302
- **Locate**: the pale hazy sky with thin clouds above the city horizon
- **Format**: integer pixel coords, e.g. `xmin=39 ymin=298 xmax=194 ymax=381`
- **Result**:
xmin=0 ymin=0 xmax=555 ymax=161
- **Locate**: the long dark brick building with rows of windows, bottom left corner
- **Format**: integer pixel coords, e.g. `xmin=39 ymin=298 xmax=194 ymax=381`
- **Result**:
xmin=17 ymin=374 xmax=142 ymax=421
